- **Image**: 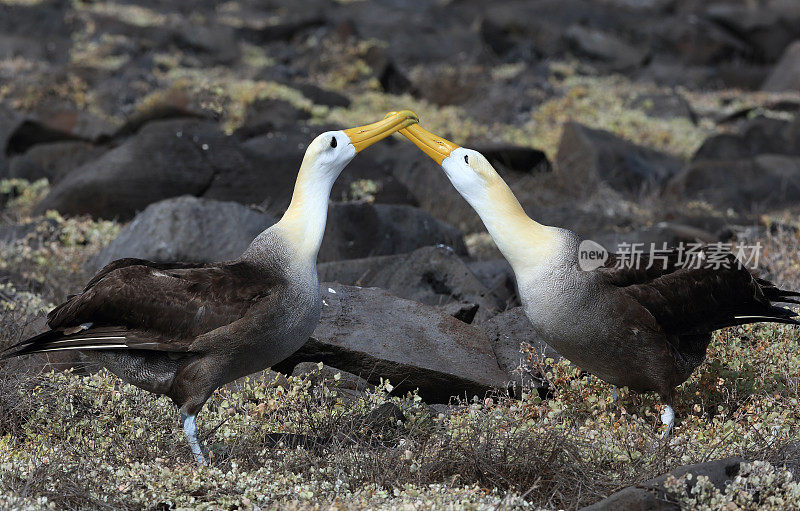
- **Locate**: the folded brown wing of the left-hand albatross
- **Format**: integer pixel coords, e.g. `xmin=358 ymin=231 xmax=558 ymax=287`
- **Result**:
xmin=3 ymin=259 xmax=283 ymax=357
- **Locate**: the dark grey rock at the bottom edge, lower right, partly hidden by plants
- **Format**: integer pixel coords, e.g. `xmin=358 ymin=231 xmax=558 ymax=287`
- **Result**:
xmin=582 ymin=457 xmax=746 ymax=511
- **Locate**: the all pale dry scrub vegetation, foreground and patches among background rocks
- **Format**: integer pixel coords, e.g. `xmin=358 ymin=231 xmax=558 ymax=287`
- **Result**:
xmin=0 ymin=0 xmax=800 ymax=504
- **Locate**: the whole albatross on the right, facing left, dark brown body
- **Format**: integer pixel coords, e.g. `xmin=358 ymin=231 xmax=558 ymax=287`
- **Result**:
xmin=400 ymin=119 xmax=800 ymax=438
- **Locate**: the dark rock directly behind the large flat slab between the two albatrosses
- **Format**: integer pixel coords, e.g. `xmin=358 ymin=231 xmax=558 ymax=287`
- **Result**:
xmin=319 ymin=245 xmax=503 ymax=323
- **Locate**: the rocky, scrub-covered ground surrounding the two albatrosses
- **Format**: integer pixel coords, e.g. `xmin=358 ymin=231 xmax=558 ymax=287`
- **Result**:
xmin=0 ymin=0 xmax=800 ymax=509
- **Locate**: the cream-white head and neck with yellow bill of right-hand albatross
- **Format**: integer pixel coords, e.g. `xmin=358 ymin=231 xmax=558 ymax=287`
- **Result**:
xmin=392 ymin=124 xmax=558 ymax=274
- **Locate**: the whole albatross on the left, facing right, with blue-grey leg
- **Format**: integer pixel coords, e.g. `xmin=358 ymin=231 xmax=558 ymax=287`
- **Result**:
xmin=2 ymin=110 xmax=416 ymax=465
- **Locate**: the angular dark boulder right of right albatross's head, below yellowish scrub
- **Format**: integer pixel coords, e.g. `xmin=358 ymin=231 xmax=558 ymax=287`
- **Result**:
xmin=556 ymin=122 xmax=681 ymax=195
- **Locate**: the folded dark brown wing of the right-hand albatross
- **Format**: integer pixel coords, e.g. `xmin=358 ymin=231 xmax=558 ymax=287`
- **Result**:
xmin=596 ymin=249 xmax=800 ymax=336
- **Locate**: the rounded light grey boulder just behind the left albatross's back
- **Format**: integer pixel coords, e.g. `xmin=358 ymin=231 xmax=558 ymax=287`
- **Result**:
xmin=90 ymin=197 xmax=275 ymax=271
